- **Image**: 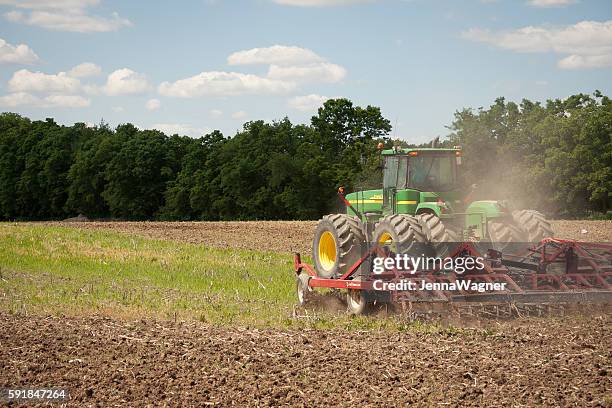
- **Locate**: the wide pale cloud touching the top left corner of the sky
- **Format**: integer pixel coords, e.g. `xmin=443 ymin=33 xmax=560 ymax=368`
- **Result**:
xmin=0 ymin=0 xmax=132 ymax=33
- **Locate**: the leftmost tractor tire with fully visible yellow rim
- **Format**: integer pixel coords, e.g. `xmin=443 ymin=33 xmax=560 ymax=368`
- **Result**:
xmin=312 ymin=214 xmax=365 ymax=278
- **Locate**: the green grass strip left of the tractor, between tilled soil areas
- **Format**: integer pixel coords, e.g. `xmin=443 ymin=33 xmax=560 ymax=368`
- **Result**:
xmin=0 ymin=223 xmax=468 ymax=332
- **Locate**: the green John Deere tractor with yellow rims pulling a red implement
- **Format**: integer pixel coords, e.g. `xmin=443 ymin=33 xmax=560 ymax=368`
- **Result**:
xmin=313 ymin=147 xmax=553 ymax=278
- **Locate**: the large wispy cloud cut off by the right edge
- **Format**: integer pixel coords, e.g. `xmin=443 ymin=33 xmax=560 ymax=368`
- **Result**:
xmin=462 ymin=20 xmax=612 ymax=68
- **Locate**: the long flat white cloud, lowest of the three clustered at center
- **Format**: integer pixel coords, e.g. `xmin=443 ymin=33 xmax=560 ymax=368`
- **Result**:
xmin=158 ymin=71 xmax=295 ymax=98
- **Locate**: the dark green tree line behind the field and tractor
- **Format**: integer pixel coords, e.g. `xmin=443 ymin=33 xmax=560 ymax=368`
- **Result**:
xmin=0 ymin=92 xmax=612 ymax=220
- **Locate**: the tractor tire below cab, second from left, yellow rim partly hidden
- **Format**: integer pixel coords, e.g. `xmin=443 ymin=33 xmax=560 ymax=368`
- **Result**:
xmin=373 ymin=214 xmax=431 ymax=255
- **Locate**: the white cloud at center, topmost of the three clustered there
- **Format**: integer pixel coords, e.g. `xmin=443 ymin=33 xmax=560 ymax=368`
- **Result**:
xmin=227 ymin=45 xmax=323 ymax=65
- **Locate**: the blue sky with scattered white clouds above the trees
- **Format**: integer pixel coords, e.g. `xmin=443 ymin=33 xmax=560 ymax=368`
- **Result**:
xmin=0 ymin=0 xmax=612 ymax=143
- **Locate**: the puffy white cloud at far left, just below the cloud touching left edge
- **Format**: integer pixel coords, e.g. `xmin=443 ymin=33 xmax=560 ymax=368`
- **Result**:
xmin=8 ymin=69 xmax=81 ymax=93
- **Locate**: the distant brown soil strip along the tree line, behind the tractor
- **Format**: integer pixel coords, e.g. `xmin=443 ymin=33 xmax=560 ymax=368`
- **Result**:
xmin=37 ymin=221 xmax=612 ymax=254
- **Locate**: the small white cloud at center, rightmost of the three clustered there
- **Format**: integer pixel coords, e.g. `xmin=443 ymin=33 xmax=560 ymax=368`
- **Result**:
xmin=268 ymin=62 xmax=346 ymax=83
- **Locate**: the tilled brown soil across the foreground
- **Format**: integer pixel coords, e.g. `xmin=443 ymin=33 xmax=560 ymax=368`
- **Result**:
xmin=0 ymin=314 xmax=612 ymax=407
